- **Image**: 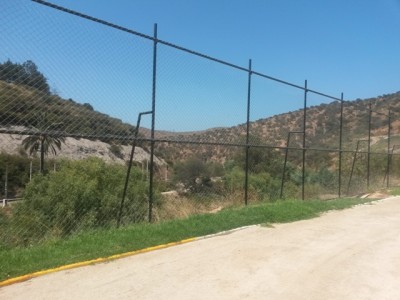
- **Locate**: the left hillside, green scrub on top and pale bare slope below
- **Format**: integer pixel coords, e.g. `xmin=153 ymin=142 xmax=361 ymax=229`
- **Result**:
xmin=0 ymin=80 xmax=164 ymax=165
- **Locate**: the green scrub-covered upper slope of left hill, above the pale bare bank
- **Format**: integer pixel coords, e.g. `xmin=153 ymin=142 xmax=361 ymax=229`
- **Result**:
xmin=0 ymin=80 xmax=134 ymax=140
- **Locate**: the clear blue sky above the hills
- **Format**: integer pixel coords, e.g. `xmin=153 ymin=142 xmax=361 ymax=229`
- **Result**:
xmin=0 ymin=0 xmax=400 ymax=131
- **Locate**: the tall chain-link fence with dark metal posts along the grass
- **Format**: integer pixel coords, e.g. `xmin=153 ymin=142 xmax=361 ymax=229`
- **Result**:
xmin=0 ymin=0 xmax=400 ymax=247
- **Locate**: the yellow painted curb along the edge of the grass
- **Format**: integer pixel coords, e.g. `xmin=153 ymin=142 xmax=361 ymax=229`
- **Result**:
xmin=0 ymin=238 xmax=197 ymax=287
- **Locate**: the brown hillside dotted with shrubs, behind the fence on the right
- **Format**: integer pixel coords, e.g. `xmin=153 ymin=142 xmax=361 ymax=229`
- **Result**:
xmin=153 ymin=92 xmax=400 ymax=162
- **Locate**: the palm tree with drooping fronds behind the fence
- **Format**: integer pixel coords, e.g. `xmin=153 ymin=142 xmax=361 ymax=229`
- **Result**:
xmin=22 ymin=114 xmax=65 ymax=174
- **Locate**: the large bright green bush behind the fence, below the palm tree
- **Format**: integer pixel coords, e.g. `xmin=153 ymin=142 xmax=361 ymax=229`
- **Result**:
xmin=0 ymin=158 xmax=148 ymax=245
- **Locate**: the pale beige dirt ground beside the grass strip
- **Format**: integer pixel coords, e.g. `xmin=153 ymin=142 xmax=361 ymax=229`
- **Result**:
xmin=0 ymin=197 xmax=400 ymax=300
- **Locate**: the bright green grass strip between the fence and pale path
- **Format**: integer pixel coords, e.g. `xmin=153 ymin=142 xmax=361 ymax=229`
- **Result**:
xmin=0 ymin=199 xmax=376 ymax=281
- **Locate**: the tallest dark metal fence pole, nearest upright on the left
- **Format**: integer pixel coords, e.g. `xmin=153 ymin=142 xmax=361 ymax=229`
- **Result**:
xmin=149 ymin=24 xmax=157 ymax=222
